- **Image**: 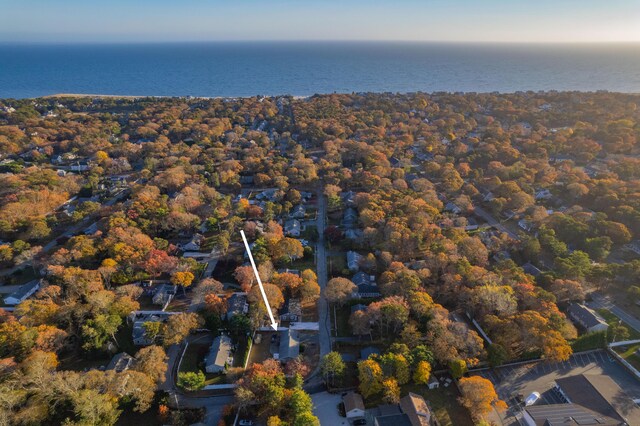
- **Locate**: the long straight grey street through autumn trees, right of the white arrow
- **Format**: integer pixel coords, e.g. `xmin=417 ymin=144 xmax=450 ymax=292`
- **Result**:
xmin=316 ymin=185 xmax=331 ymax=357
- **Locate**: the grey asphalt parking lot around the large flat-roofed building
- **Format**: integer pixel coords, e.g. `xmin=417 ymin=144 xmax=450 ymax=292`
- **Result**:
xmin=472 ymin=350 xmax=640 ymax=425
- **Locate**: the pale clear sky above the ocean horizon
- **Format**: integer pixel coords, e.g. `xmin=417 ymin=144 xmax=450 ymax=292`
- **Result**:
xmin=0 ymin=0 xmax=640 ymax=42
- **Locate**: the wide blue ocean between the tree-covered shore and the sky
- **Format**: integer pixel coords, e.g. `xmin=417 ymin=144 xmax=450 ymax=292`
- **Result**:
xmin=0 ymin=42 xmax=640 ymax=98
